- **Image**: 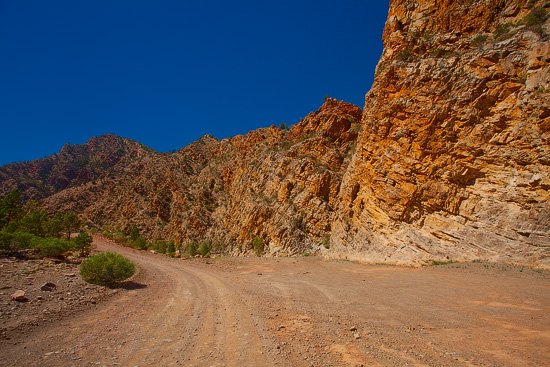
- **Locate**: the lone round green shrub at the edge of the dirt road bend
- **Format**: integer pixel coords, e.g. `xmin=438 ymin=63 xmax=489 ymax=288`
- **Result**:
xmin=80 ymin=252 xmax=136 ymax=288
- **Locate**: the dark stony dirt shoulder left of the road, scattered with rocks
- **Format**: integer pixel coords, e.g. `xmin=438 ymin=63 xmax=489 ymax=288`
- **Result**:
xmin=0 ymin=257 xmax=120 ymax=340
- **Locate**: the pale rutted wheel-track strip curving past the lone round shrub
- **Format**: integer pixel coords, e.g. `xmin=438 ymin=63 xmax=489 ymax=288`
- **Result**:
xmin=98 ymin=239 xmax=272 ymax=367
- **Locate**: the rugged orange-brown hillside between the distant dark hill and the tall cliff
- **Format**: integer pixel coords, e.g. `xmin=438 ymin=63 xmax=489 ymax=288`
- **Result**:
xmin=35 ymin=99 xmax=362 ymax=255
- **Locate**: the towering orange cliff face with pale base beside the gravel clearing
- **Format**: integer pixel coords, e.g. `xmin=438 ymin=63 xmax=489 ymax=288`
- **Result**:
xmin=331 ymin=0 xmax=550 ymax=267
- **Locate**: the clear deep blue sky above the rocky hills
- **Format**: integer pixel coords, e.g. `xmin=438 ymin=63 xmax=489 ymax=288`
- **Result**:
xmin=0 ymin=0 xmax=389 ymax=165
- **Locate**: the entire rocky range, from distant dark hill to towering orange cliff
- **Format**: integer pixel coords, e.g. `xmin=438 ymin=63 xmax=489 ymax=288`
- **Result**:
xmin=0 ymin=0 xmax=550 ymax=267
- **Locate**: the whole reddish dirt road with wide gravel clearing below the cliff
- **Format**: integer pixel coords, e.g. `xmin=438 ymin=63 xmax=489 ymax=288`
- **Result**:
xmin=0 ymin=239 xmax=550 ymax=366
